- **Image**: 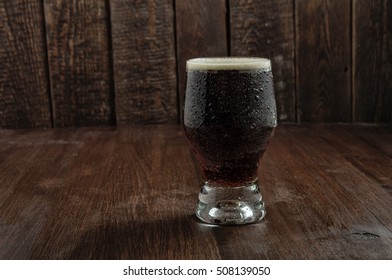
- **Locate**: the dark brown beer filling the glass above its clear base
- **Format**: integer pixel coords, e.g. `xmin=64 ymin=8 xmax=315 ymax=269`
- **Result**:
xmin=183 ymin=59 xmax=276 ymax=186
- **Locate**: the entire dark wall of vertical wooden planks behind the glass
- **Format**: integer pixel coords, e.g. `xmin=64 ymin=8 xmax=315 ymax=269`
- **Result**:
xmin=0 ymin=0 xmax=392 ymax=128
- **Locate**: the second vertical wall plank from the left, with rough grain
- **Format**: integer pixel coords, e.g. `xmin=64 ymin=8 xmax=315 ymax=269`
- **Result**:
xmin=44 ymin=0 xmax=115 ymax=127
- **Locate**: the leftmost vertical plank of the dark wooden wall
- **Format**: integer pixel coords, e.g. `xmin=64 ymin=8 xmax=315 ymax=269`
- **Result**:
xmin=0 ymin=0 xmax=52 ymax=128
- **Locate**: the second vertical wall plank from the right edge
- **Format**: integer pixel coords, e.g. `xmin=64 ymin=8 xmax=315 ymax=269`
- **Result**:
xmin=295 ymin=0 xmax=352 ymax=122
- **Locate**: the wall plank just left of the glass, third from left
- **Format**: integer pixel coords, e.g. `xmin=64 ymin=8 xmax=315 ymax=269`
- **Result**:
xmin=110 ymin=0 xmax=178 ymax=124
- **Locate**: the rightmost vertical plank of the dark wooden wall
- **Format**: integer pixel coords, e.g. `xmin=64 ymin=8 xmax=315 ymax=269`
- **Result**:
xmin=353 ymin=0 xmax=392 ymax=122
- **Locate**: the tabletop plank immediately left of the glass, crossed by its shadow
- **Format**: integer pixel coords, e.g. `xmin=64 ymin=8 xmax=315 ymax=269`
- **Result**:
xmin=64 ymin=126 xmax=219 ymax=259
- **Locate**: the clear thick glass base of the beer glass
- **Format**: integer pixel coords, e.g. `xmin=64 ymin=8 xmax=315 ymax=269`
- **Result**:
xmin=196 ymin=181 xmax=266 ymax=225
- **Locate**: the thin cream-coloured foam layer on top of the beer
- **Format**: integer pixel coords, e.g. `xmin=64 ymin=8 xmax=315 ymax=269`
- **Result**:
xmin=186 ymin=57 xmax=271 ymax=71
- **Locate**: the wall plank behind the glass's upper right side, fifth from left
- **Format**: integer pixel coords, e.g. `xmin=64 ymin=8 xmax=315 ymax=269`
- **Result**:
xmin=230 ymin=0 xmax=295 ymax=121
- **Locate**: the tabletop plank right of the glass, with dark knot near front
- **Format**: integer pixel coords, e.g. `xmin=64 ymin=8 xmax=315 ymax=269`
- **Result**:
xmin=260 ymin=126 xmax=392 ymax=259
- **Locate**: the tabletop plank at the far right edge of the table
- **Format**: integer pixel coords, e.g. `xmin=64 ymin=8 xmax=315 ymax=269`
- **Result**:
xmin=316 ymin=125 xmax=392 ymax=203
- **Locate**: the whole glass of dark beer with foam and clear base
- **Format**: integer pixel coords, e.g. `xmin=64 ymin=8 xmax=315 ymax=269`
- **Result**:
xmin=183 ymin=57 xmax=277 ymax=224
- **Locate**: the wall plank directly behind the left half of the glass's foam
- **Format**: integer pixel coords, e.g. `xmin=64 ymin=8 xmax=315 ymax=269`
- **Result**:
xmin=175 ymin=0 xmax=229 ymax=121
